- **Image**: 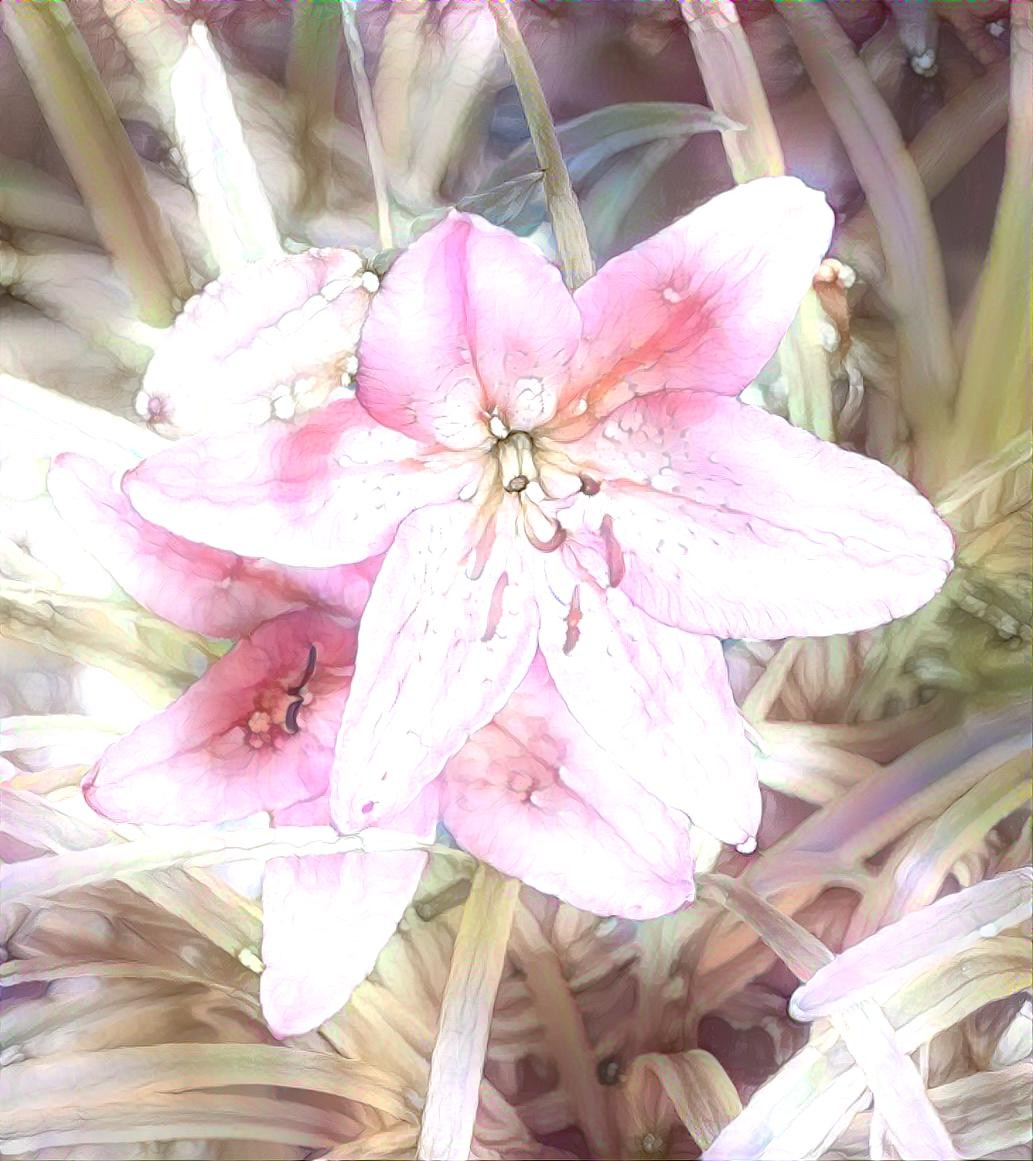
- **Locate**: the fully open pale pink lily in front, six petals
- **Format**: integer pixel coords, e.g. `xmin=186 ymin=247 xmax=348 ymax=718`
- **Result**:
xmin=125 ymin=178 xmax=952 ymax=849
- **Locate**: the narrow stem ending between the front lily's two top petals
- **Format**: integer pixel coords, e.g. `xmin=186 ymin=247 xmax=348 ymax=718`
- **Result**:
xmin=486 ymin=0 xmax=595 ymax=289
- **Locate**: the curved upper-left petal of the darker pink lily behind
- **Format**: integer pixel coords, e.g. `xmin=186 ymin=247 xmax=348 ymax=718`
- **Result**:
xmin=48 ymin=454 xmax=380 ymax=637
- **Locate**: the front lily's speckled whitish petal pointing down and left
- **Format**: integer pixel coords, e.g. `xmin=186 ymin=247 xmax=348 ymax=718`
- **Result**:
xmin=332 ymin=503 xmax=537 ymax=830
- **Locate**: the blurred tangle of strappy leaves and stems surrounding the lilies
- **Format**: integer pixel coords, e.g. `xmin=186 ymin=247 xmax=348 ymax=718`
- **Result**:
xmin=0 ymin=0 xmax=1033 ymax=1159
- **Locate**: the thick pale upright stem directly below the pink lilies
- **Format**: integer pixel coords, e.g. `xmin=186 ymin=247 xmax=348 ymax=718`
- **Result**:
xmin=417 ymin=865 xmax=520 ymax=1161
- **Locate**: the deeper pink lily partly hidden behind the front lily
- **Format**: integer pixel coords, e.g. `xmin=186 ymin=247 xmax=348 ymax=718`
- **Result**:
xmin=49 ymin=455 xmax=693 ymax=1036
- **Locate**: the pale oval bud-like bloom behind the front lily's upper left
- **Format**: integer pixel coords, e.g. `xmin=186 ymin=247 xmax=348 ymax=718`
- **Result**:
xmin=137 ymin=250 xmax=370 ymax=434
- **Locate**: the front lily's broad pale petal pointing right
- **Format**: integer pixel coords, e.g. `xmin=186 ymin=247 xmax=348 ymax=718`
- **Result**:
xmin=569 ymin=391 xmax=953 ymax=639
